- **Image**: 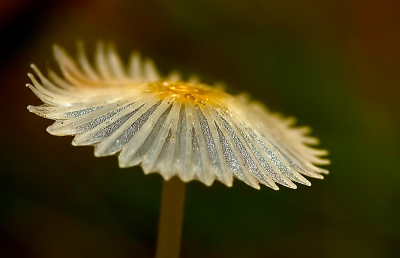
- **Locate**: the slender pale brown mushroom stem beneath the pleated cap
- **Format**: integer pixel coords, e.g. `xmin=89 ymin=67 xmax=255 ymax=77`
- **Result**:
xmin=156 ymin=177 xmax=186 ymax=258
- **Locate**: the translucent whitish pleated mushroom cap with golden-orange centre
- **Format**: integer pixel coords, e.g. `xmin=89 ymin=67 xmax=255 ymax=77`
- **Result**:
xmin=27 ymin=43 xmax=329 ymax=190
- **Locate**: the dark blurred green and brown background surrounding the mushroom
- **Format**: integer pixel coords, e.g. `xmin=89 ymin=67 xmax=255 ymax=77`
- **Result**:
xmin=0 ymin=0 xmax=400 ymax=258
